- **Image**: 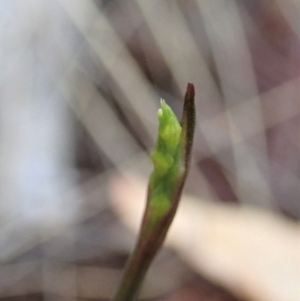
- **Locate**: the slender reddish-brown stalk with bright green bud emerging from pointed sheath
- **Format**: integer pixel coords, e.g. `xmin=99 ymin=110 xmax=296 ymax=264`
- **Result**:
xmin=113 ymin=84 xmax=195 ymax=301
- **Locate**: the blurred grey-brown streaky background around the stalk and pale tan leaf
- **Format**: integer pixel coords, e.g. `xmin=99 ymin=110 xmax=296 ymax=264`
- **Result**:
xmin=0 ymin=0 xmax=300 ymax=301
